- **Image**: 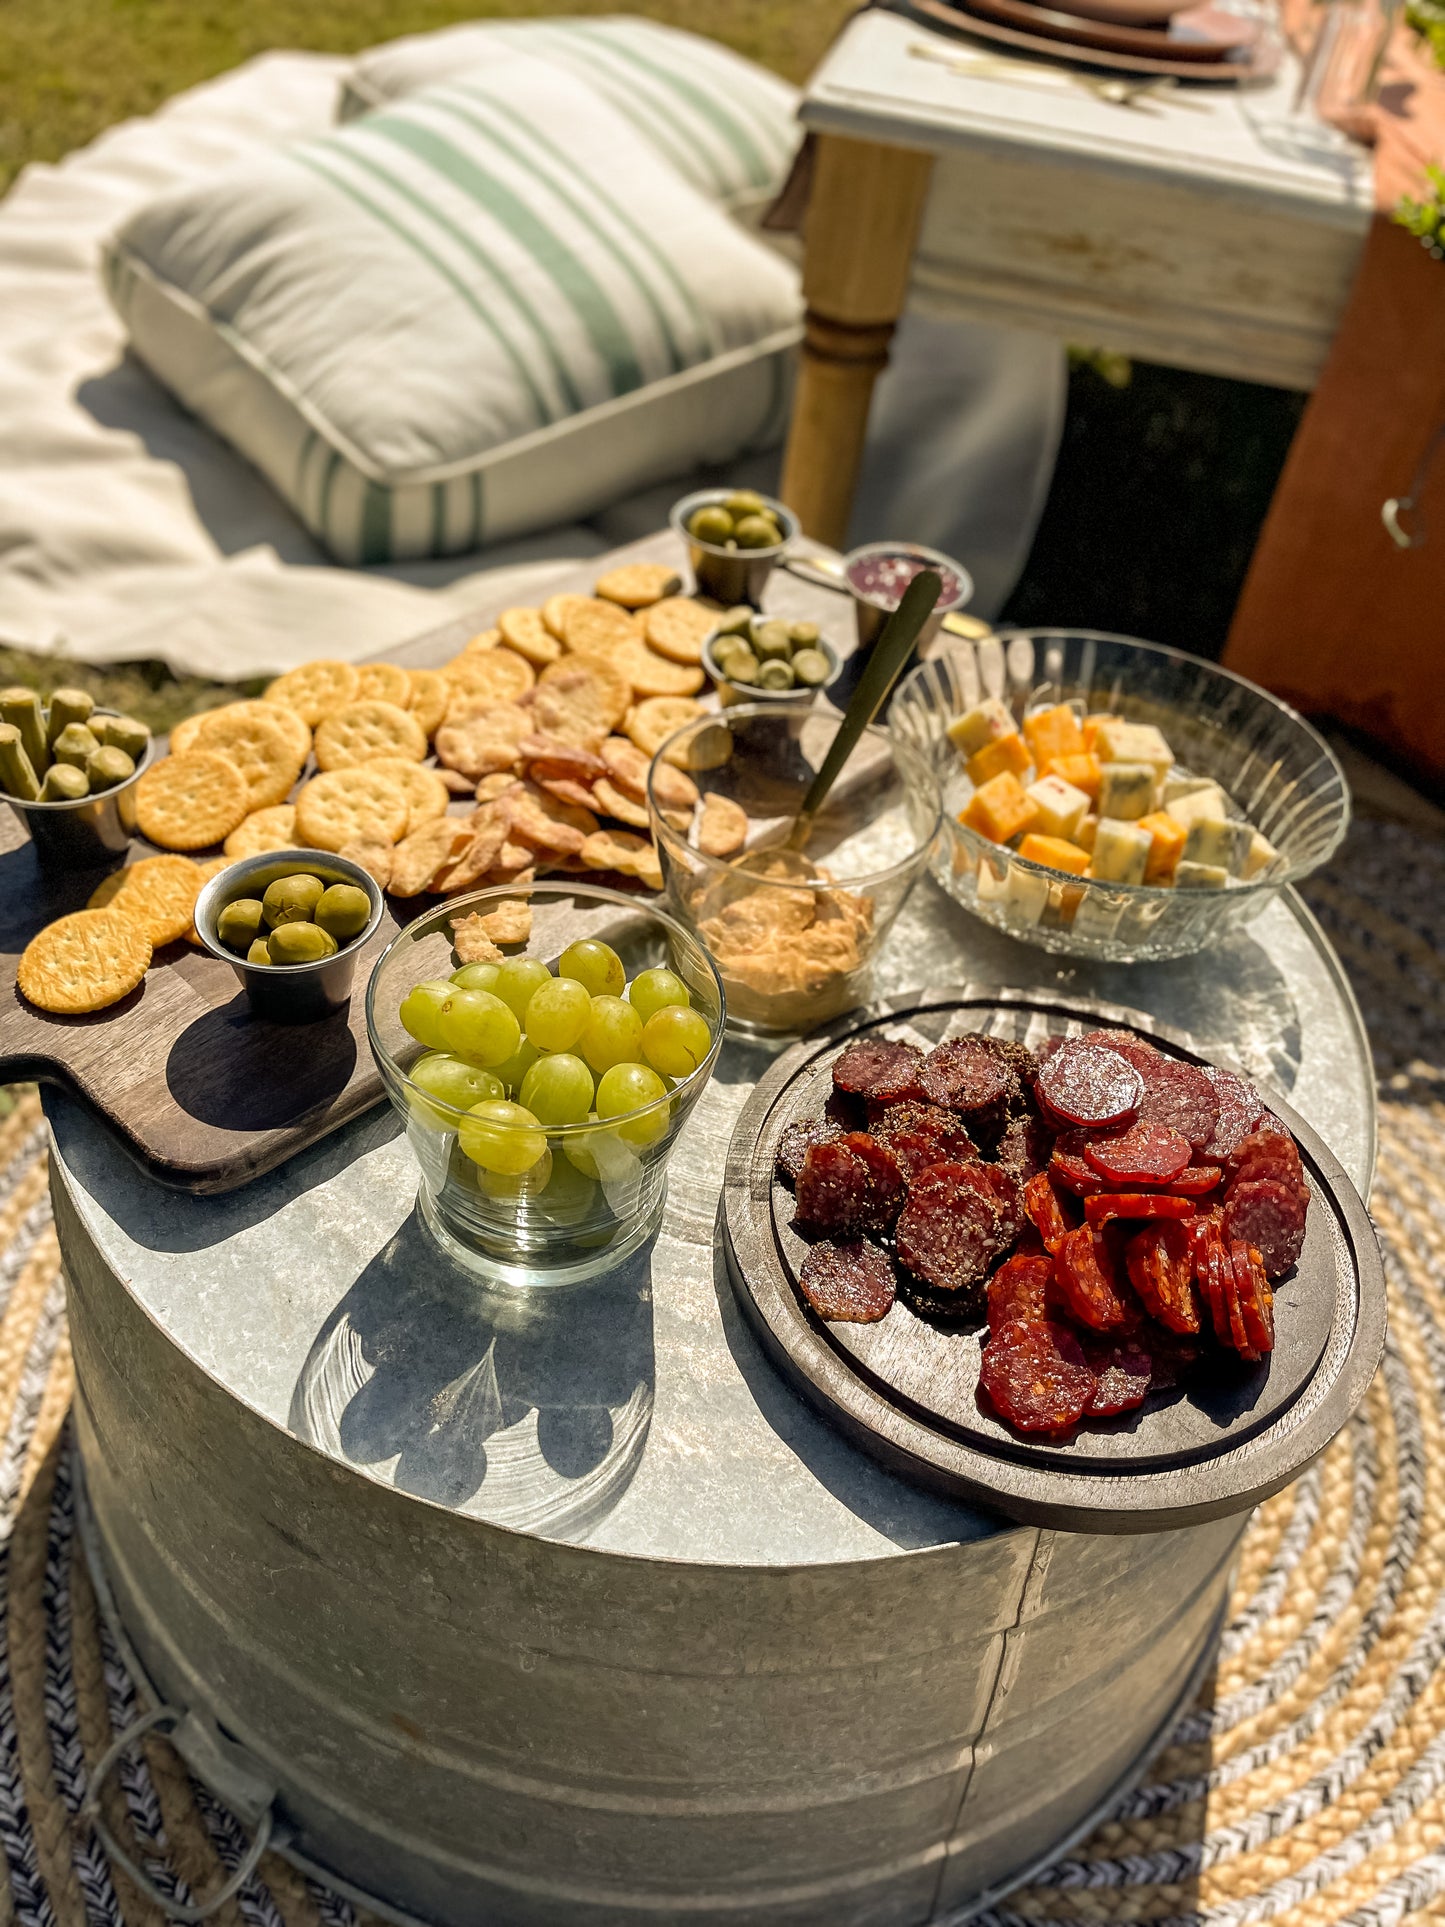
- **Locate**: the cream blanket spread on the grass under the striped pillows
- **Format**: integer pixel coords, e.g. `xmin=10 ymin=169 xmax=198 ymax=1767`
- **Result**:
xmin=0 ymin=54 xmax=1064 ymax=680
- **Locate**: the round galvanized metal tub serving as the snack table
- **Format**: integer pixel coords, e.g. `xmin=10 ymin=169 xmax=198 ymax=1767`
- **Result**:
xmin=46 ymin=883 xmax=1374 ymax=1927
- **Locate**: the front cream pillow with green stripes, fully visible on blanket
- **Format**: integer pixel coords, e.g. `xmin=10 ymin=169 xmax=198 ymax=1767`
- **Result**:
xmin=106 ymin=64 xmax=800 ymax=563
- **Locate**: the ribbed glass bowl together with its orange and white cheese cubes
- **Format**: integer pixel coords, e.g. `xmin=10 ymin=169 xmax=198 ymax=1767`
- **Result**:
xmin=888 ymin=630 xmax=1349 ymax=964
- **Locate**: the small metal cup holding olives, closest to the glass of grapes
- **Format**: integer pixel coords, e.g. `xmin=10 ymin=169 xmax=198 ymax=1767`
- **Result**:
xmin=197 ymin=850 xmax=385 ymax=1023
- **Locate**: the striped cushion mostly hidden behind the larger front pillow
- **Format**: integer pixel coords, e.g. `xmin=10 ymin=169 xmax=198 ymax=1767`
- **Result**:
xmin=341 ymin=15 xmax=800 ymax=212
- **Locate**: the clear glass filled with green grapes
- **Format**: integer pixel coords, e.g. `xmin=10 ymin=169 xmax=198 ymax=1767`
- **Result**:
xmin=366 ymin=881 xmax=726 ymax=1289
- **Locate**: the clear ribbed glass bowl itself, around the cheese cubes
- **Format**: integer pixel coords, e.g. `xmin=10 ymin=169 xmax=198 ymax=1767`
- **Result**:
xmin=888 ymin=628 xmax=1351 ymax=964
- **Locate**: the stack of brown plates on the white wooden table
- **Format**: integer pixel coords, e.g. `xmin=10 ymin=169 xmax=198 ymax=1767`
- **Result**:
xmin=906 ymin=0 xmax=1277 ymax=83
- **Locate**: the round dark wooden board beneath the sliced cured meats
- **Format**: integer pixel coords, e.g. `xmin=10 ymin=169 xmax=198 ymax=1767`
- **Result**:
xmin=723 ymin=985 xmax=1385 ymax=1532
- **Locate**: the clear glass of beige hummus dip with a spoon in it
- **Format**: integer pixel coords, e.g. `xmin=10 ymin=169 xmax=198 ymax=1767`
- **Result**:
xmin=647 ymin=703 xmax=942 ymax=1041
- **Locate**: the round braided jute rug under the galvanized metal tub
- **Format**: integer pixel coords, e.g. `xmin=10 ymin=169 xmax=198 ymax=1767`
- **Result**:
xmin=0 ymin=821 xmax=1445 ymax=1927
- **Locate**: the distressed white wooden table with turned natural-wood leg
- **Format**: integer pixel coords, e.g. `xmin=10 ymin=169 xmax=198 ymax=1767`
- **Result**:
xmin=782 ymin=12 xmax=1374 ymax=545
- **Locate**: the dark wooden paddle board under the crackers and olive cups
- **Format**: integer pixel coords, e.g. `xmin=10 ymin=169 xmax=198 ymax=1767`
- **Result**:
xmin=0 ymin=532 xmax=854 ymax=1193
